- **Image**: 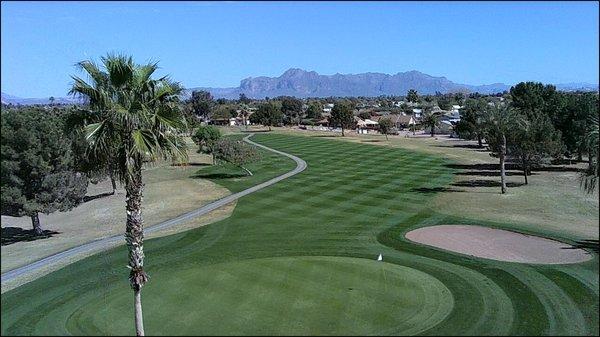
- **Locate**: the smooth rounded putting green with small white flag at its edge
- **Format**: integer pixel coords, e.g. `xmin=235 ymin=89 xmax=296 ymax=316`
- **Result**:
xmin=66 ymin=257 xmax=453 ymax=335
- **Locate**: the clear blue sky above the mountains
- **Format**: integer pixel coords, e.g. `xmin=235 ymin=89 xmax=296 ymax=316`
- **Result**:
xmin=1 ymin=1 xmax=599 ymax=97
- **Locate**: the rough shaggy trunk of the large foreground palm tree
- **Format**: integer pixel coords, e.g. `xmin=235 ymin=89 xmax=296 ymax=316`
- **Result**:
xmin=125 ymin=156 xmax=148 ymax=336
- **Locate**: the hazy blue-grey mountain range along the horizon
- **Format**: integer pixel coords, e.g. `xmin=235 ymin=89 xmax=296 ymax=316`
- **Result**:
xmin=2 ymin=68 xmax=598 ymax=104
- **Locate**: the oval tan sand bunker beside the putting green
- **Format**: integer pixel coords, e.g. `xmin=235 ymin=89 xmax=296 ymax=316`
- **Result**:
xmin=406 ymin=225 xmax=592 ymax=264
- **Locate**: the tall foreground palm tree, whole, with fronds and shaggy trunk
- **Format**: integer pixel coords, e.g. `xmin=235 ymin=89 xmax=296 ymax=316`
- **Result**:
xmin=70 ymin=55 xmax=187 ymax=336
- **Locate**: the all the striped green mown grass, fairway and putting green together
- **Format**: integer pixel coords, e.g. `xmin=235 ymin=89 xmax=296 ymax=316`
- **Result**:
xmin=1 ymin=134 xmax=599 ymax=335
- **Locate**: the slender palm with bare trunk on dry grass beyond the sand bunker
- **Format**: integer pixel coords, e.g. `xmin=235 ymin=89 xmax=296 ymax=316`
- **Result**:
xmin=483 ymin=104 xmax=524 ymax=194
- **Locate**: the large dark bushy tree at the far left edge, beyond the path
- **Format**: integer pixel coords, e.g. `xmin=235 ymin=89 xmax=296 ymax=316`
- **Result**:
xmin=0 ymin=108 xmax=87 ymax=235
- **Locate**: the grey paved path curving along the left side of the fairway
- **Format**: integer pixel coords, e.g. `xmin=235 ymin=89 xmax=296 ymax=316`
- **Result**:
xmin=0 ymin=134 xmax=307 ymax=283
